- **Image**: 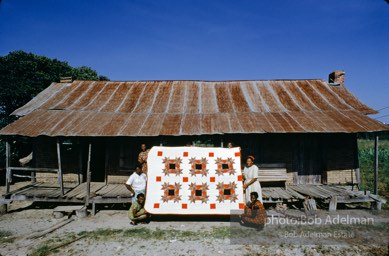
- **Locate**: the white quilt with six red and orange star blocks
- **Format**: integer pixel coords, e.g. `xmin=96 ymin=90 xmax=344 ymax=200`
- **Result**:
xmin=145 ymin=147 xmax=244 ymax=214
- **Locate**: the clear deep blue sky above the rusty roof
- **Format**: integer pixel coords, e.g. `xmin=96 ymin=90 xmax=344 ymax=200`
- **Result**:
xmin=0 ymin=0 xmax=389 ymax=123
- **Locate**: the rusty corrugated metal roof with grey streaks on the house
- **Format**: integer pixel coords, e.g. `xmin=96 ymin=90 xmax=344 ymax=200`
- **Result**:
xmin=0 ymin=80 xmax=388 ymax=137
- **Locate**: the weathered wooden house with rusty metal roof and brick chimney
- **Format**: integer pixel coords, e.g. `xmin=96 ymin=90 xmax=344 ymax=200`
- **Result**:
xmin=0 ymin=71 xmax=388 ymax=211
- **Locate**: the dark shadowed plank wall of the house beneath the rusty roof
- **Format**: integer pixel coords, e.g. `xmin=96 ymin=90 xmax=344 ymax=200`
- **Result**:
xmin=30 ymin=134 xmax=358 ymax=184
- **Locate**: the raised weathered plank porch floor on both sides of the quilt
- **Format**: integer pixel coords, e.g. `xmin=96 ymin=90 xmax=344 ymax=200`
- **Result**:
xmin=0 ymin=182 xmax=381 ymax=215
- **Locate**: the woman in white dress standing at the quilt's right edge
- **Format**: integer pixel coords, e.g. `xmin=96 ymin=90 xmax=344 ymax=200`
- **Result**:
xmin=243 ymin=156 xmax=262 ymax=203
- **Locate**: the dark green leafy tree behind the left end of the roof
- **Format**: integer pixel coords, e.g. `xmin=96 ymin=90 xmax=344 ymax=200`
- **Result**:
xmin=0 ymin=51 xmax=108 ymax=127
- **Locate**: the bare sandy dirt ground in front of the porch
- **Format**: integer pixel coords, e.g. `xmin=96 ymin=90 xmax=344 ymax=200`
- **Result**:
xmin=0 ymin=184 xmax=389 ymax=255
